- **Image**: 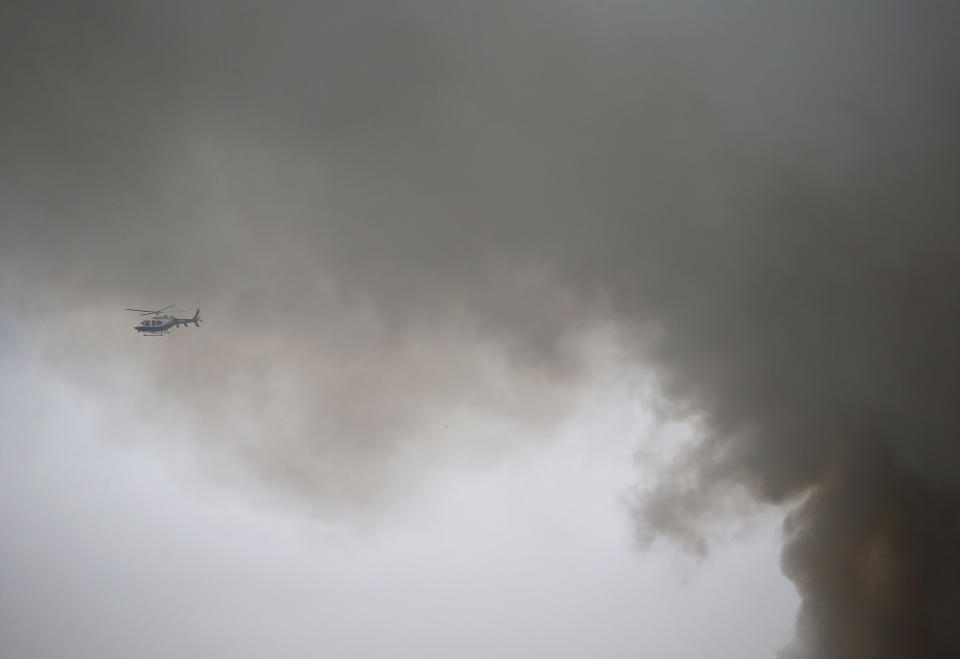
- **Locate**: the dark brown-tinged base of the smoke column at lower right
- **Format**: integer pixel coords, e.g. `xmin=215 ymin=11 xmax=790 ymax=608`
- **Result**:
xmin=784 ymin=456 xmax=960 ymax=657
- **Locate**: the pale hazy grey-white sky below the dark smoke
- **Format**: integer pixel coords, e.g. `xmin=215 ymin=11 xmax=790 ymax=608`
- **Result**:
xmin=0 ymin=348 xmax=797 ymax=659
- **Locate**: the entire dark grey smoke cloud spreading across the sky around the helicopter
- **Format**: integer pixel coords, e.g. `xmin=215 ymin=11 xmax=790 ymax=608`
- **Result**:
xmin=0 ymin=0 xmax=960 ymax=658
